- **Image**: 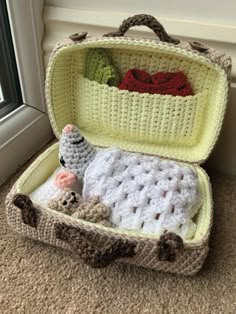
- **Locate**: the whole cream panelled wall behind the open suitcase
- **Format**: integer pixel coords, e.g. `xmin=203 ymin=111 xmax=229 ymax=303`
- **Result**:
xmin=43 ymin=0 xmax=236 ymax=175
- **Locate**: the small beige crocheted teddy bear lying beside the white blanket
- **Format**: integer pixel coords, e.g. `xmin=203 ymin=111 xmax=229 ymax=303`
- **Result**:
xmin=48 ymin=191 xmax=112 ymax=227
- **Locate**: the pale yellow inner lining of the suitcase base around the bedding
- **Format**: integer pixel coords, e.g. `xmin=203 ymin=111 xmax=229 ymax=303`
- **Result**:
xmin=15 ymin=143 xmax=212 ymax=247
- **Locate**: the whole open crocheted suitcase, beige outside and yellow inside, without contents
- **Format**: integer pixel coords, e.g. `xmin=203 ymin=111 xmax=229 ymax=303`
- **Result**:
xmin=6 ymin=15 xmax=231 ymax=275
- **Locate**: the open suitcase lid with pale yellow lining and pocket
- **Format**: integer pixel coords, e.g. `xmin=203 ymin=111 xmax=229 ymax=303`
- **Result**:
xmin=46 ymin=37 xmax=231 ymax=163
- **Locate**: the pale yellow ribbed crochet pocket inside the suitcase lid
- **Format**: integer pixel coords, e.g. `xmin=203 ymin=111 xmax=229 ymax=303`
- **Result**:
xmin=77 ymin=75 xmax=207 ymax=146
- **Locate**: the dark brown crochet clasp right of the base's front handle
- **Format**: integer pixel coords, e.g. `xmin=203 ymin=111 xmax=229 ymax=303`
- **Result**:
xmin=158 ymin=232 xmax=184 ymax=262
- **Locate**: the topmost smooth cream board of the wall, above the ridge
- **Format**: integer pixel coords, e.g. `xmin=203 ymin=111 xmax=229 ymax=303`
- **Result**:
xmin=46 ymin=0 xmax=236 ymax=24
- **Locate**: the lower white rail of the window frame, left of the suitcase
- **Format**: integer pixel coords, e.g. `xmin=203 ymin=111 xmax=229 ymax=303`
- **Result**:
xmin=0 ymin=105 xmax=53 ymax=184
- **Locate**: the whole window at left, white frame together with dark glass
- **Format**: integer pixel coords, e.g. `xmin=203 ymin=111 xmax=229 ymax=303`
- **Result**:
xmin=0 ymin=0 xmax=52 ymax=185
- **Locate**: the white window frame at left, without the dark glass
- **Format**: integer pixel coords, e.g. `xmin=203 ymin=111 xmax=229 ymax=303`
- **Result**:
xmin=0 ymin=0 xmax=52 ymax=184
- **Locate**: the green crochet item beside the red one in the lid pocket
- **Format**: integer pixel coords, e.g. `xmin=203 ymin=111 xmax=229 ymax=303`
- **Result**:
xmin=85 ymin=48 xmax=120 ymax=86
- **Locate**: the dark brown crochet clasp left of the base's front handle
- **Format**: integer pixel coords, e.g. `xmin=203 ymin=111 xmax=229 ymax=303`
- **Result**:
xmin=12 ymin=193 xmax=40 ymax=228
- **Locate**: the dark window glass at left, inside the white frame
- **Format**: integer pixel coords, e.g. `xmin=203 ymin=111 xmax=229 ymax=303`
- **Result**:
xmin=0 ymin=1 xmax=22 ymax=119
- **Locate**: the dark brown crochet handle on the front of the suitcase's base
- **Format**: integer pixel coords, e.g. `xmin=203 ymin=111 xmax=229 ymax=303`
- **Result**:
xmin=55 ymin=224 xmax=135 ymax=268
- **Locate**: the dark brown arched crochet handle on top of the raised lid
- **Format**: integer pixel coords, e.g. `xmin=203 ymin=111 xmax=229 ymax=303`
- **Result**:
xmin=103 ymin=14 xmax=180 ymax=45
